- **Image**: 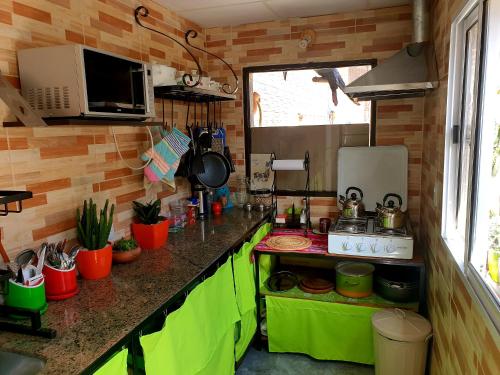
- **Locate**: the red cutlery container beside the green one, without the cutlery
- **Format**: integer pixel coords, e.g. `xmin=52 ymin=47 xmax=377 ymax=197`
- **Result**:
xmin=42 ymin=264 xmax=79 ymax=301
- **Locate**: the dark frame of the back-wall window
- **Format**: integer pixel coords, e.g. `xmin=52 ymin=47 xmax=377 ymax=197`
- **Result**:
xmin=242 ymin=59 xmax=377 ymax=197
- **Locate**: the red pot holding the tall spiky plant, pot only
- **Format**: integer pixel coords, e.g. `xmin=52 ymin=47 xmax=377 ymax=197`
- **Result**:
xmin=76 ymin=245 xmax=113 ymax=280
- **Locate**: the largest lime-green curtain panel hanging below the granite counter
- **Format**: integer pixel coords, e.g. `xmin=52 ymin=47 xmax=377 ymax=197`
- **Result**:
xmin=141 ymin=259 xmax=240 ymax=375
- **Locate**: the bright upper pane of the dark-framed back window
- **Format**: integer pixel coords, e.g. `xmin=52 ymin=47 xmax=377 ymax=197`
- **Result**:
xmin=251 ymin=65 xmax=371 ymax=127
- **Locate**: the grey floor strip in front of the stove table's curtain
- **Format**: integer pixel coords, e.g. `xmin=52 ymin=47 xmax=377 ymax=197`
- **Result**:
xmin=236 ymin=348 xmax=375 ymax=375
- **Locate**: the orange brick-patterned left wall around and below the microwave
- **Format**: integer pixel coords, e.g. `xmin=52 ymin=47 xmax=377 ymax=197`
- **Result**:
xmin=0 ymin=0 xmax=205 ymax=255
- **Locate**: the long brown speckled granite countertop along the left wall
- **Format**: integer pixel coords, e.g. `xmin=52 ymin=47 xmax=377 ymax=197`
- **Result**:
xmin=0 ymin=208 xmax=270 ymax=374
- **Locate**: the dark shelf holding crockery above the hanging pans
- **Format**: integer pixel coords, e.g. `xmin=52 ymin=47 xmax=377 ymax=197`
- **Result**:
xmin=155 ymin=85 xmax=236 ymax=103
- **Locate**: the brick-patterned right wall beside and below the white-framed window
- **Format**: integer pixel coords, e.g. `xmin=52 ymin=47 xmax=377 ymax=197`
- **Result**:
xmin=421 ymin=0 xmax=500 ymax=375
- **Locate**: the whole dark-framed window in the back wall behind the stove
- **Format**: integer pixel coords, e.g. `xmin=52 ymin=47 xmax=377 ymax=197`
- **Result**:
xmin=243 ymin=60 xmax=375 ymax=196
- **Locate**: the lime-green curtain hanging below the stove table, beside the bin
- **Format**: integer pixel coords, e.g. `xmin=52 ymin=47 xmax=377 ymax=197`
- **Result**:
xmin=266 ymin=296 xmax=380 ymax=364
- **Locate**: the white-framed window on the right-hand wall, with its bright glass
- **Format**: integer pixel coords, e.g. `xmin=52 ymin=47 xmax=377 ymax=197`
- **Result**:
xmin=442 ymin=0 xmax=500 ymax=327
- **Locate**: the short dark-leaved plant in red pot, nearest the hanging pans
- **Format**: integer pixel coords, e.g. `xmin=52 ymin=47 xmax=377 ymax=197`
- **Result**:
xmin=132 ymin=199 xmax=169 ymax=250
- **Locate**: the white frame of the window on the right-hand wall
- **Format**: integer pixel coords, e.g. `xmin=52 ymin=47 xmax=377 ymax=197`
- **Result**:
xmin=441 ymin=0 xmax=500 ymax=331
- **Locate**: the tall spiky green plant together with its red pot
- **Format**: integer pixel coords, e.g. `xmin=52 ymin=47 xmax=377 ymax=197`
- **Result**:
xmin=76 ymin=199 xmax=115 ymax=280
